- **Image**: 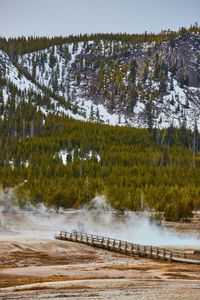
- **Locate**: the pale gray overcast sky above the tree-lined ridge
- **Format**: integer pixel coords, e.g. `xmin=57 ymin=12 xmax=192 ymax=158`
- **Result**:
xmin=0 ymin=0 xmax=200 ymax=37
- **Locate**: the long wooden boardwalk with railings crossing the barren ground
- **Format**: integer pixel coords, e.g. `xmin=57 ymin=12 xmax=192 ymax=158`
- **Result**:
xmin=55 ymin=231 xmax=200 ymax=264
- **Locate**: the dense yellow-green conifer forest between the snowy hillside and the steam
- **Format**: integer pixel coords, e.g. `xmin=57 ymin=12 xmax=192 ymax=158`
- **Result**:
xmin=0 ymin=108 xmax=200 ymax=219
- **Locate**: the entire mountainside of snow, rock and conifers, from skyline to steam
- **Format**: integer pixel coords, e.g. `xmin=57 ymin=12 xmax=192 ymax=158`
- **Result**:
xmin=0 ymin=26 xmax=200 ymax=220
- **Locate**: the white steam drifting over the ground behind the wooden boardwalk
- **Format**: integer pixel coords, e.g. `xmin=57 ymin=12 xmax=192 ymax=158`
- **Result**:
xmin=0 ymin=191 xmax=200 ymax=249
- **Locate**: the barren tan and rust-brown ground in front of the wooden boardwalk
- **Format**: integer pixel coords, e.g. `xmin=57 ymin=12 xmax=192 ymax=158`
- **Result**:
xmin=0 ymin=212 xmax=200 ymax=300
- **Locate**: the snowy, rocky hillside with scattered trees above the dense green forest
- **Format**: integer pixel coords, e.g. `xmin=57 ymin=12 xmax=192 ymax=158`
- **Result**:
xmin=0 ymin=33 xmax=200 ymax=128
